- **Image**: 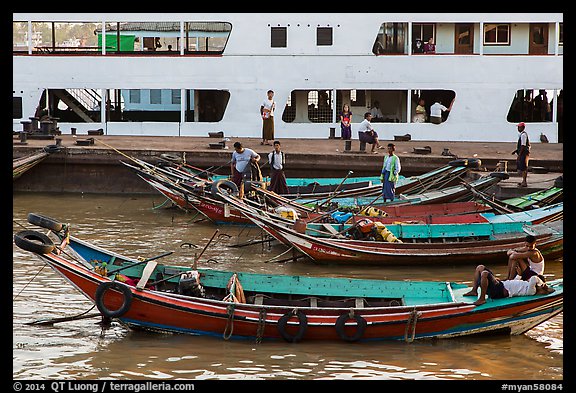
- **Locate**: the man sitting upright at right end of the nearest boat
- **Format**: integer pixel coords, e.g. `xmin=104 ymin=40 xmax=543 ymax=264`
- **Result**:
xmin=507 ymin=235 xmax=546 ymax=281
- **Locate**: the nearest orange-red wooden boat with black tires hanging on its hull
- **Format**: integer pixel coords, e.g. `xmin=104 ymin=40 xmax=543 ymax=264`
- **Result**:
xmin=14 ymin=213 xmax=563 ymax=343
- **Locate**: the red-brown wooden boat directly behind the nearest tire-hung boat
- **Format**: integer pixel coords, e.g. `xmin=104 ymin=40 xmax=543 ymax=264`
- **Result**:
xmin=222 ymin=191 xmax=564 ymax=265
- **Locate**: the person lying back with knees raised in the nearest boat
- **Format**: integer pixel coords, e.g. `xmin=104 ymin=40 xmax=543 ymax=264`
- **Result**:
xmin=463 ymin=265 xmax=554 ymax=306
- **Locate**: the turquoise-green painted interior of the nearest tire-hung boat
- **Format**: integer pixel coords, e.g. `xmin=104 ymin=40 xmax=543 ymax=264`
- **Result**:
xmin=68 ymin=236 xmax=563 ymax=310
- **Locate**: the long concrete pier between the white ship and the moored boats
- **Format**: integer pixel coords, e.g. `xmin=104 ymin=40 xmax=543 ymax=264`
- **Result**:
xmin=12 ymin=135 xmax=563 ymax=198
